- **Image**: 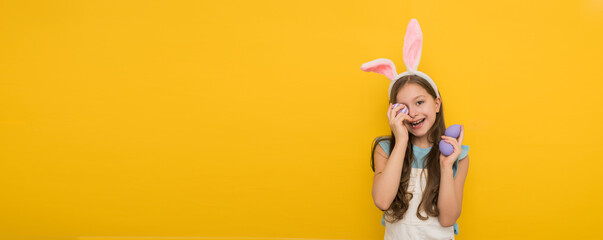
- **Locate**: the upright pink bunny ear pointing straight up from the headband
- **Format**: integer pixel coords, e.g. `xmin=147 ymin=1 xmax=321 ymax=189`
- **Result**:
xmin=402 ymin=18 xmax=423 ymax=71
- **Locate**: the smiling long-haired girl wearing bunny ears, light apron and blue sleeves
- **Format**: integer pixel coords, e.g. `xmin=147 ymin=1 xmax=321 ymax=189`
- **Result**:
xmin=361 ymin=19 xmax=469 ymax=240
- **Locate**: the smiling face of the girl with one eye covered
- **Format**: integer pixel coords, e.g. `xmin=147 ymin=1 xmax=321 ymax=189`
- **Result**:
xmin=396 ymin=83 xmax=441 ymax=137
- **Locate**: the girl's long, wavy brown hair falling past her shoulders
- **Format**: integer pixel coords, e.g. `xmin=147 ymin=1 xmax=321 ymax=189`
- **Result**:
xmin=371 ymin=75 xmax=446 ymax=222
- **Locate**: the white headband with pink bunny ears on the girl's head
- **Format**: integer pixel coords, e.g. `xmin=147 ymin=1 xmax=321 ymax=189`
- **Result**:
xmin=360 ymin=18 xmax=440 ymax=98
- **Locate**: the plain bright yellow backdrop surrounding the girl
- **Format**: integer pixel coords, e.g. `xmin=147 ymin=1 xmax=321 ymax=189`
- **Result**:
xmin=0 ymin=0 xmax=603 ymax=239
